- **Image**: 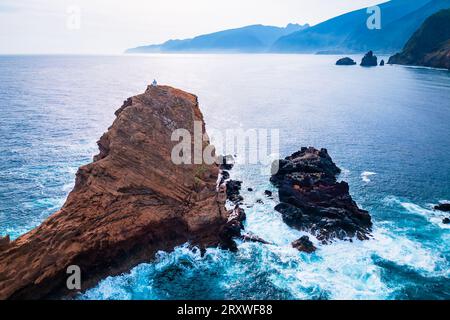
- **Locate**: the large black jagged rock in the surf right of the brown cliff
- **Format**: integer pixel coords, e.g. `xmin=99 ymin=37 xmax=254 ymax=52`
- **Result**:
xmin=271 ymin=148 xmax=372 ymax=244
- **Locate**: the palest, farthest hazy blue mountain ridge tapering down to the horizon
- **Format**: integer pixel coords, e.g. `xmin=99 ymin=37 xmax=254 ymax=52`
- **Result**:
xmin=126 ymin=24 xmax=309 ymax=53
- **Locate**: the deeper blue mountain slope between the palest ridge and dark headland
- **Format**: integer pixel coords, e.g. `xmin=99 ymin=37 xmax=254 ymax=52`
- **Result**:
xmin=271 ymin=0 xmax=450 ymax=52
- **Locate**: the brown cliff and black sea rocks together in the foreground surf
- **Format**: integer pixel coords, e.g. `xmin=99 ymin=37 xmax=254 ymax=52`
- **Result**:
xmin=0 ymin=86 xmax=372 ymax=299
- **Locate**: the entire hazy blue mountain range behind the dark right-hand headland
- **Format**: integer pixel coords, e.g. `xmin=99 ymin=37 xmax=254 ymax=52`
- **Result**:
xmin=126 ymin=0 xmax=450 ymax=53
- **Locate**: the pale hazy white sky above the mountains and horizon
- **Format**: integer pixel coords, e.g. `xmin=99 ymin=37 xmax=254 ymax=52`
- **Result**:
xmin=0 ymin=0 xmax=387 ymax=54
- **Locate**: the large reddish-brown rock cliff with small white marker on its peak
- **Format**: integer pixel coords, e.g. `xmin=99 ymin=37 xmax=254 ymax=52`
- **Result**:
xmin=0 ymin=86 xmax=227 ymax=299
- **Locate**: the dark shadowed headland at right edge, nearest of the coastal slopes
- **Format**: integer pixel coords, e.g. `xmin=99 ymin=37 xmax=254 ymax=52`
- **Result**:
xmin=388 ymin=9 xmax=450 ymax=69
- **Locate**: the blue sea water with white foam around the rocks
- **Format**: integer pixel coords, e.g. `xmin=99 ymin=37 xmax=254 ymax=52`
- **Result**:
xmin=0 ymin=55 xmax=450 ymax=299
